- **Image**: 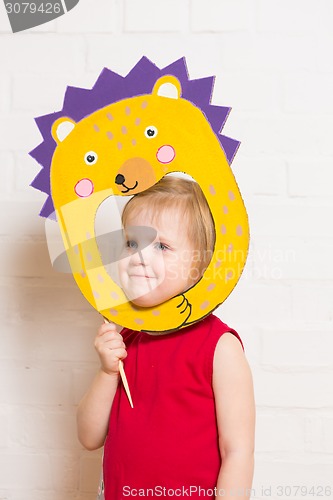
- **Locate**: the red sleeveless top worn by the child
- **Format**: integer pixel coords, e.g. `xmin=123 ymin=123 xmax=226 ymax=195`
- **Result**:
xmin=103 ymin=314 xmax=242 ymax=500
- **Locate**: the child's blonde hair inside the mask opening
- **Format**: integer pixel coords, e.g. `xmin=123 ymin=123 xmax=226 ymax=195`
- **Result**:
xmin=122 ymin=175 xmax=215 ymax=277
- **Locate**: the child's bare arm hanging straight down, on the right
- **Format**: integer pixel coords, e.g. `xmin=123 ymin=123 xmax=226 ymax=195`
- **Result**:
xmin=213 ymin=333 xmax=255 ymax=500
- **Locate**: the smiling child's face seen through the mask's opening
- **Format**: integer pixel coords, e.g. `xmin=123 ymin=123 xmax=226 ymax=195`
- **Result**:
xmin=118 ymin=210 xmax=198 ymax=307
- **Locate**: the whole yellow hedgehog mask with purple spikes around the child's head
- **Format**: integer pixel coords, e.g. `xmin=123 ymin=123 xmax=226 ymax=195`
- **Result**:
xmin=30 ymin=57 xmax=249 ymax=331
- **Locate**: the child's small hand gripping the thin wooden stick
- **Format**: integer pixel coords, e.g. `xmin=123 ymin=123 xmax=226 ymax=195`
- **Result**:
xmin=95 ymin=323 xmax=127 ymax=375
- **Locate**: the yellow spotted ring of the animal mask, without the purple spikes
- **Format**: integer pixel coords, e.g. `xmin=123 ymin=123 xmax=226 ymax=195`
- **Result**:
xmin=32 ymin=57 xmax=249 ymax=331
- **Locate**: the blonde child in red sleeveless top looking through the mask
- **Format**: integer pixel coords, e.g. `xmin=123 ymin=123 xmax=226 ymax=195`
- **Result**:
xmin=77 ymin=176 xmax=255 ymax=500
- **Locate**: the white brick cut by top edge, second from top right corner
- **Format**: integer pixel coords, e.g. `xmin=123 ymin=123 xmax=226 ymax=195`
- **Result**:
xmin=191 ymin=0 xmax=250 ymax=32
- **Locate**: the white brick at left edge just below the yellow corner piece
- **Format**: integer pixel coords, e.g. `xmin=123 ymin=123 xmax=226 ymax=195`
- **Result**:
xmin=0 ymin=32 xmax=85 ymax=73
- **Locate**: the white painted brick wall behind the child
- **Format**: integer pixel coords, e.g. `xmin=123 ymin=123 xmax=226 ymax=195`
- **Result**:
xmin=0 ymin=0 xmax=333 ymax=500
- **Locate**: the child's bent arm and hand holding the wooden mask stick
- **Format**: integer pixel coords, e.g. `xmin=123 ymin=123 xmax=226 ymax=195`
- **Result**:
xmin=77 ymin=323 xmax=127 ymax=450
